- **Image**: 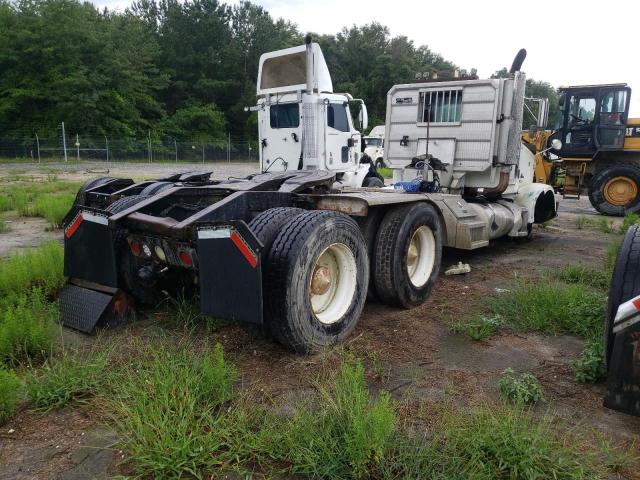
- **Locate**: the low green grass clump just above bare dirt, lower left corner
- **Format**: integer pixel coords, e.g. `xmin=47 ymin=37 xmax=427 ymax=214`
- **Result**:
xmin=26 ymin=352 xmax=108 ymax=411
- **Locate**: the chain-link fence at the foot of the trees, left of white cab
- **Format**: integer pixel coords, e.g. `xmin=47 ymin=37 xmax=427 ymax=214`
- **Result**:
xmin=0 ymin=130 xmax=258 ymax=163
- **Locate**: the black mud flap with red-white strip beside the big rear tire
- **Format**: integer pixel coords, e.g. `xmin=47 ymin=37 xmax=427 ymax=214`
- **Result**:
xmin=198 ymin=221 xmax=262 ymax=324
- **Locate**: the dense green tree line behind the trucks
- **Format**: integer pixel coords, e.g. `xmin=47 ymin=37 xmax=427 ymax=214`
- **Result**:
xmin=0 ymin=0 xmax=555 ymax=143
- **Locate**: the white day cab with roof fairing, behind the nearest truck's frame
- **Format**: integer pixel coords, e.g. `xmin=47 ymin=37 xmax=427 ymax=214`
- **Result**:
xmin=251 ymin=37 xmax=372 ymax=187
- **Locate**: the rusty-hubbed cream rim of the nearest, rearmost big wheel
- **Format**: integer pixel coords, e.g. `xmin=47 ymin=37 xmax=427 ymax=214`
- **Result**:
xmin=309 ymin=243 xmax=357 ymax=325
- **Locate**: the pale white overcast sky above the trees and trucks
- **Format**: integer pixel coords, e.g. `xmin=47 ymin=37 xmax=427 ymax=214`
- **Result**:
xmin=94 ymin=0 xmax=640 ymax=117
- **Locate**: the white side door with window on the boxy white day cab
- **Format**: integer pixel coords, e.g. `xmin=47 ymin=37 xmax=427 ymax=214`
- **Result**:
xmin=325 ymin=102 xmax=357 ymax=171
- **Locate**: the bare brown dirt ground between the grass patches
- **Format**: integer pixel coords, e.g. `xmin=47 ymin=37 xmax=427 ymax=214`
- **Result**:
xmin=0 ymin=165 xmax=640 ymax=480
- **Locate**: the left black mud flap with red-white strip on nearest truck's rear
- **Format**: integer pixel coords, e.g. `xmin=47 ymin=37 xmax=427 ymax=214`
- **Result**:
xmin=64 ymin=208 xmax=118 ymax=288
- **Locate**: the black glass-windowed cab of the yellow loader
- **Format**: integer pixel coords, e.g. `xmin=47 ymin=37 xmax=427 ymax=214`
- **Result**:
xmin=553 ymin=84 xmax=631 ymax=157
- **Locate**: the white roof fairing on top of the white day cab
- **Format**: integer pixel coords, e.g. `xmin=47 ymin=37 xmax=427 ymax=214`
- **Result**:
xmin=256 ymin=43 xmax=333 ymax=95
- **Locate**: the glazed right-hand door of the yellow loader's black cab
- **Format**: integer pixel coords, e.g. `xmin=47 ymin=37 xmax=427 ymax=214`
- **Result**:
xmin=596 ymin=87 xmax=631 ymax=150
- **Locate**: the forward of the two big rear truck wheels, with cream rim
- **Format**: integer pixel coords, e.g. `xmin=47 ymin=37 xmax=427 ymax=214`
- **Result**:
xmin=372 ymin=202 xmax=442 ymax=308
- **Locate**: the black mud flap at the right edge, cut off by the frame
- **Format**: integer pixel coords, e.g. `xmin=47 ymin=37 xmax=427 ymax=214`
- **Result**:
xmin=604 ymin=315 xmax=640 ymax=416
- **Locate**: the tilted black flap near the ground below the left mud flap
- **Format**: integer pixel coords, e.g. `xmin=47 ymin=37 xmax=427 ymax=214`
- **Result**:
xmin=58 ymin=283 xmax=135 ymax=333
